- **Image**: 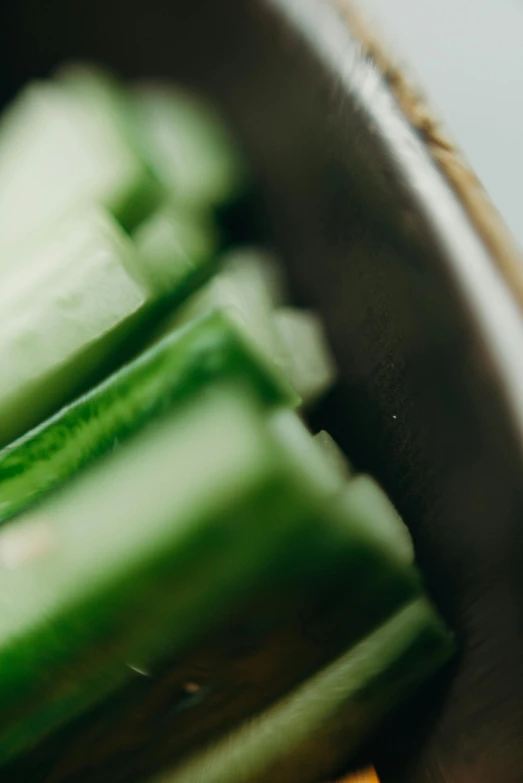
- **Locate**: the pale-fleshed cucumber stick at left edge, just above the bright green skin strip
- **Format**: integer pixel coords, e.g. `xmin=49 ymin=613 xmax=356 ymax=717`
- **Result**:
xmin=0 ymin=209 xmax=150 ymax=445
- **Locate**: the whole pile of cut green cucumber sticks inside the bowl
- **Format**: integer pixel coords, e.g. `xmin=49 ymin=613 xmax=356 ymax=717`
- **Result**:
xmin=0 ymin=66 xmax=452 ymax=783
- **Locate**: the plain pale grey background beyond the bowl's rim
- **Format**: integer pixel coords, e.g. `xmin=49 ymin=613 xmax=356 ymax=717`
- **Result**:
xmin=360 ymin=0 xmax=523 ymax=248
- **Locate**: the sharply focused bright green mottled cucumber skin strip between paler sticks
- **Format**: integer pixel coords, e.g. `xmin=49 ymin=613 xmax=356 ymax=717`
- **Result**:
xmin=0 ymin=312 xmax=298 ymax=523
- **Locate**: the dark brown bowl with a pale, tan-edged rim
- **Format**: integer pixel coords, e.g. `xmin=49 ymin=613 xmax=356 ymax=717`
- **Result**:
xmin=0 ymin=0 xmax=523 ymax=783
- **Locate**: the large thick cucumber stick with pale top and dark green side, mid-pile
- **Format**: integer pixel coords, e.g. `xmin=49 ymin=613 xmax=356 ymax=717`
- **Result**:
xmin=0 ymin=387 xmax=430 ymax=760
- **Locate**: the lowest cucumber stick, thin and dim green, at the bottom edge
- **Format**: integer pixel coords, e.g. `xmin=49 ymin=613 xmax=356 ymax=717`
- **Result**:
xmin=161 ymin=599 xmax=452 ymax=783
